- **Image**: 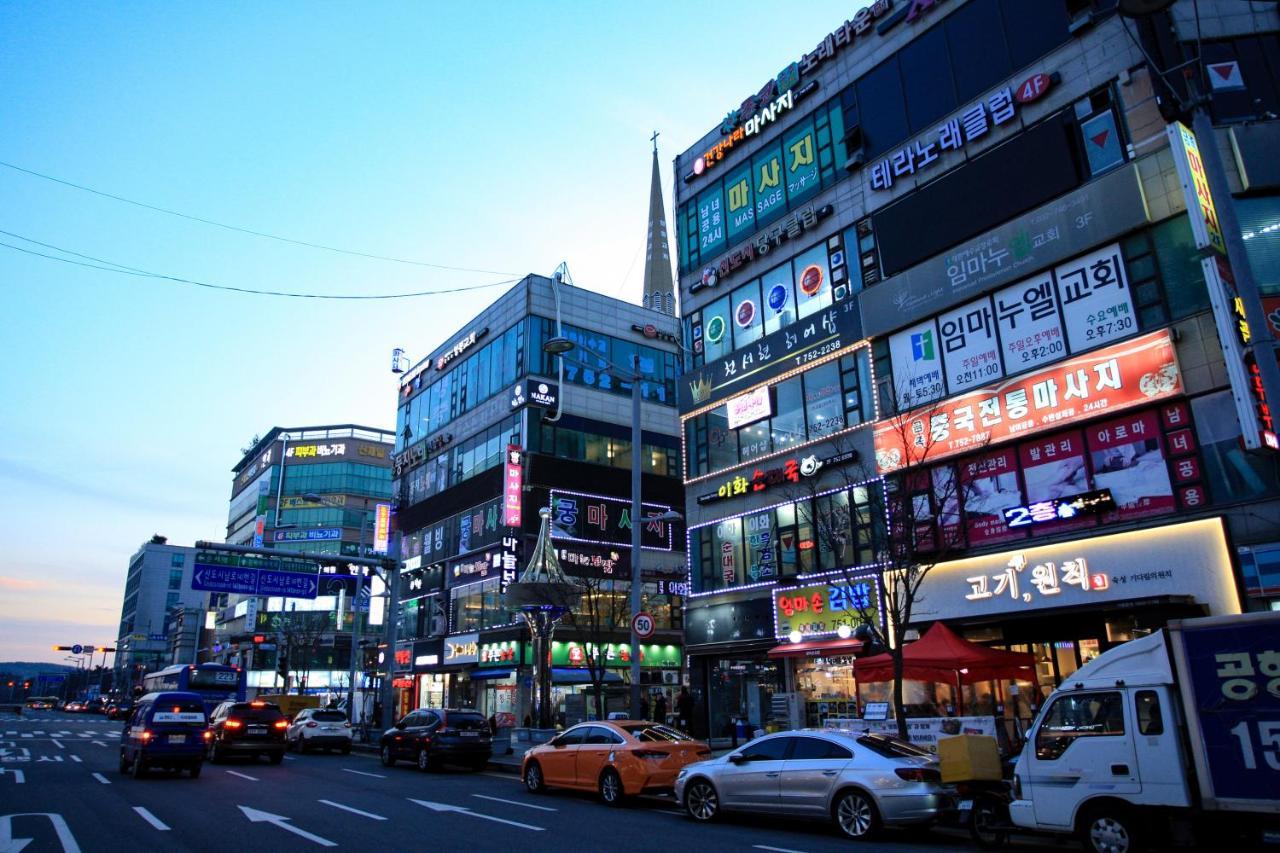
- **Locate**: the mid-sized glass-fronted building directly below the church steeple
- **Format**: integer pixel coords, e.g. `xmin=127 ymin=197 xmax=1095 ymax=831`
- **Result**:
xmin=393 ymin=275 xmax=685 ymax=725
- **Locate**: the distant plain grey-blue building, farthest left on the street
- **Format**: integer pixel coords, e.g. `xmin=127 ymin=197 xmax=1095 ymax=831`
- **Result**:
xmin=115 ymin=535 xmax=205 ymax=684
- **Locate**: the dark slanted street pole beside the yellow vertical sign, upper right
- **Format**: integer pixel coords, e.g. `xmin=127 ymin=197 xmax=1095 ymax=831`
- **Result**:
xmin=1187 ymin=99 xmax=1280 ymax=430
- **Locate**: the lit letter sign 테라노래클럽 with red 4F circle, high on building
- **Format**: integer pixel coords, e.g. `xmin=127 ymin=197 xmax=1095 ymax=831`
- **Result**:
xmin=870 ymin=74 xmax=1056 ymax=190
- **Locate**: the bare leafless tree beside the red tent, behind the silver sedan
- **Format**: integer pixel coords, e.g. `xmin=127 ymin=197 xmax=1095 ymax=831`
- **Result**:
xmin=788 ymin=396 xmax=988 ymax=739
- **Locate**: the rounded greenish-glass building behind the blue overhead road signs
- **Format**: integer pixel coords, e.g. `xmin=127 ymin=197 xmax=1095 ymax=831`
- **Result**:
xmin=210 ymin=424 xmax=394 ymax=693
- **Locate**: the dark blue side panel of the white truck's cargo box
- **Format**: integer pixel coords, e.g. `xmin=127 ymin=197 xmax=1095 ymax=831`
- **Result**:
xmin=1170 ymin=613 xmax=1280 ymax=809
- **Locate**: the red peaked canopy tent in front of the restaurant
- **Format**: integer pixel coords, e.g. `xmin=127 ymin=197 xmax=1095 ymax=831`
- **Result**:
xmin=854 ymin=622 xmax=1036 ymax=684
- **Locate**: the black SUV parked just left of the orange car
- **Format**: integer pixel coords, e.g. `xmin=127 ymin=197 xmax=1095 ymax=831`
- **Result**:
xmin=378 ymin=708 xmax=493 ymax=771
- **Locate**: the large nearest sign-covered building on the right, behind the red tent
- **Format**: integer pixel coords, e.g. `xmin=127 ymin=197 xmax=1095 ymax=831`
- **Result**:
xmin=675 ymin=0 xmax=1280 ymax=736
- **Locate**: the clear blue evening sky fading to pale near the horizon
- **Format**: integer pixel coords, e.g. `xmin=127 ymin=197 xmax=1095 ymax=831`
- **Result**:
xmin=0 ymin=0 xmax=865 ymax=662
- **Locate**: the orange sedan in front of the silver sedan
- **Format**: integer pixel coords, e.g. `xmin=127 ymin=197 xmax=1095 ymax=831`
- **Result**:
xmin=520 ymin=720 xmax=712 ymax=806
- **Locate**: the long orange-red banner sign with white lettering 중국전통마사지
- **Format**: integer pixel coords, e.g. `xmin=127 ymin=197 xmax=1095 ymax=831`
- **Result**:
xmin=874 ymin=329 xmax=1183 ymax=474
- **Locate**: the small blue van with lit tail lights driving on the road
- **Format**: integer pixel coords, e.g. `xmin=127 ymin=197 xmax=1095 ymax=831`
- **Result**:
xmin=120 ymin=692 xmax=210 ymax=779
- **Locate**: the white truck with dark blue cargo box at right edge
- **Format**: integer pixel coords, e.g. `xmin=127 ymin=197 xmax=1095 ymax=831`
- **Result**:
xmin=1009 ymin=612 xmax=1280 ymax=853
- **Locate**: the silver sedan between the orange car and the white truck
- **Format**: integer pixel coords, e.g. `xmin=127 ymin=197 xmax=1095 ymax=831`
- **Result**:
xmin=676 ymin=729 xmax=952 ymax=840
